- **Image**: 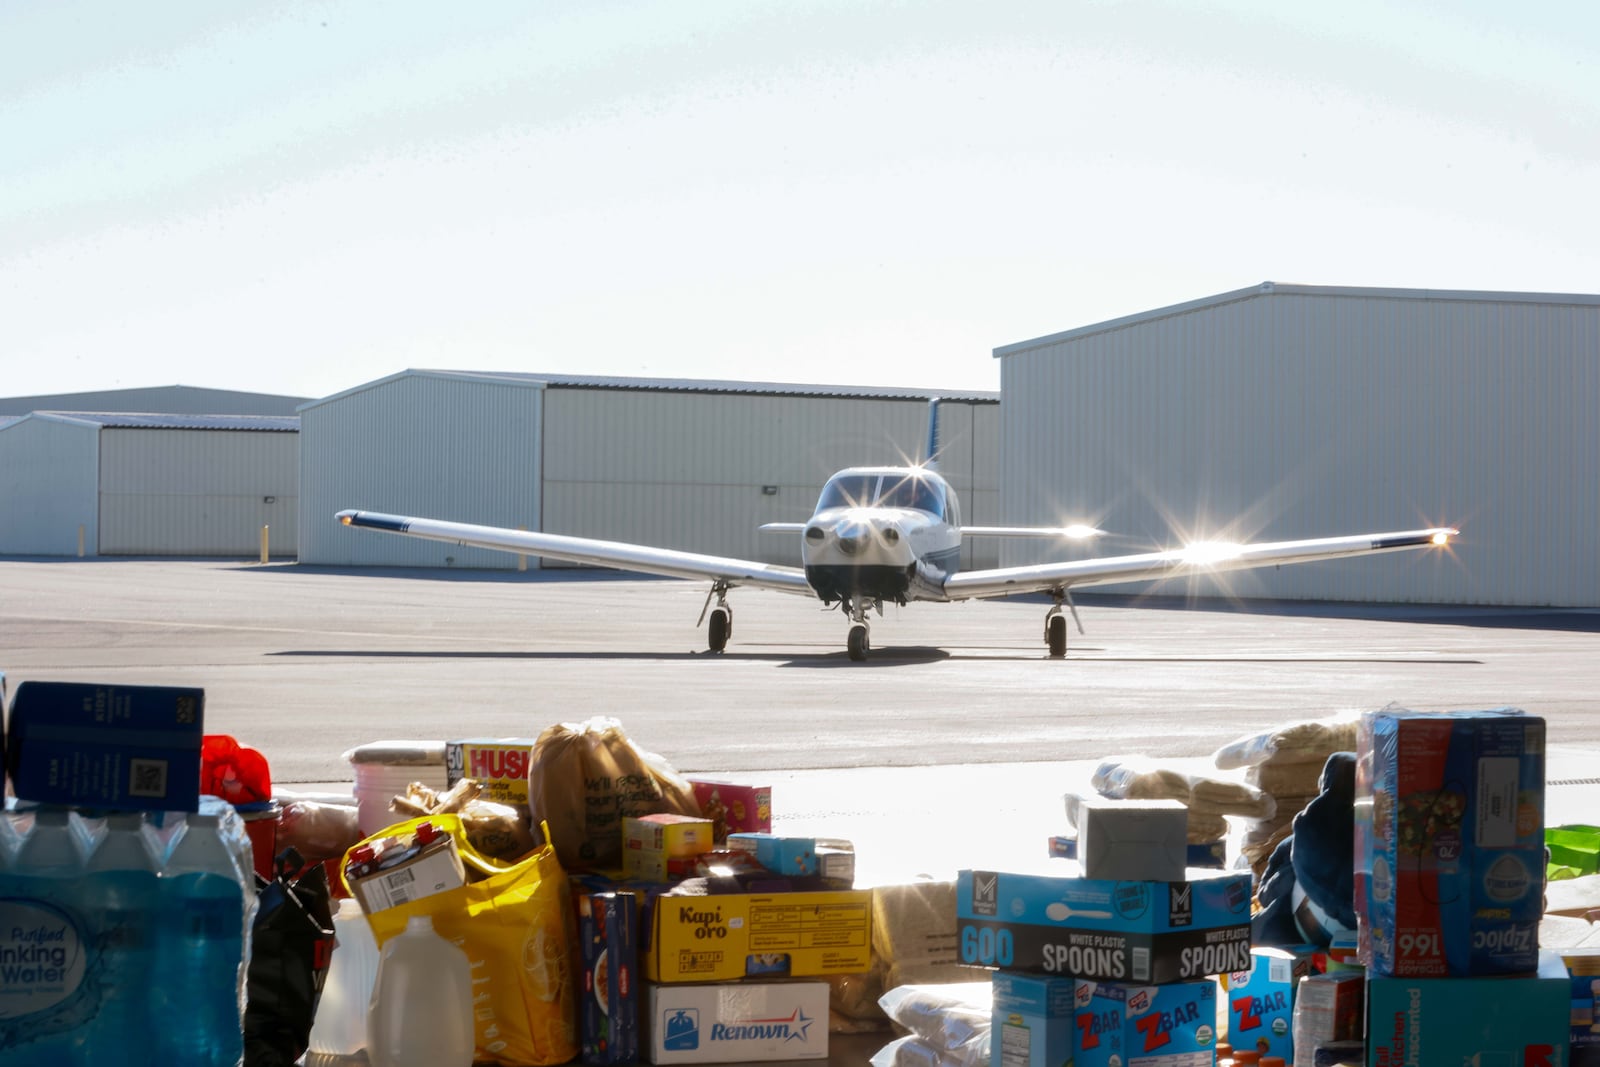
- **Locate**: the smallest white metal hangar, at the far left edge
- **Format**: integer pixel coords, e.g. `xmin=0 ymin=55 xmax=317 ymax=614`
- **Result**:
xmin=0 ymin=412 xmax=299 ymax=558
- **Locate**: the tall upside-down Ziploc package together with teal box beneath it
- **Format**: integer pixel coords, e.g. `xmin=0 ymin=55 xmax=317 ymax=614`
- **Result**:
xmin=1355 ymin=709 xmax=1570 ymax=1067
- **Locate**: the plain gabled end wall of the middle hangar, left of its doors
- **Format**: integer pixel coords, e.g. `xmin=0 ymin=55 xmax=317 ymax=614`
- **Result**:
xmin=299 ymin=373 xmax=542 ymax=568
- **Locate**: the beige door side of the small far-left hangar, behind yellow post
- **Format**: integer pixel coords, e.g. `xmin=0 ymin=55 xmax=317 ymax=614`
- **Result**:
xmin=99 ymin=427 xmax=299 ymax=557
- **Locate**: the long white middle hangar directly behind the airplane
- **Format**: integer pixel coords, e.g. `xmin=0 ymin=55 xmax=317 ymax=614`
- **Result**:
xmin=298 ymin=370 xmax=1002 ymax=568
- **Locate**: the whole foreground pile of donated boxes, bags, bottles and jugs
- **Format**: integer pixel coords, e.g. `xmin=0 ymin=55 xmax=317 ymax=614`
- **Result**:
xmin=9 ymin=677 xmax=1600 ymax=1067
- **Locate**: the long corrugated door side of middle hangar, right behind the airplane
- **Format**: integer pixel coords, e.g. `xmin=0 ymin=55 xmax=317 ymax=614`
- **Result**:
xmin=544 ymin=386 xmax=998 ymax=566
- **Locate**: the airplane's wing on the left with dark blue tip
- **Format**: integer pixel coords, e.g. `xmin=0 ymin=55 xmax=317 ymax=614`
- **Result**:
xmin=334 ymin=509 xmax=816 ymax=597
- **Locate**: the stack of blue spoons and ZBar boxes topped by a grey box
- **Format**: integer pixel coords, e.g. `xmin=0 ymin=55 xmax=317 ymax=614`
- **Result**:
xmin=957 ymin=801 xmax=1251 ymax=1067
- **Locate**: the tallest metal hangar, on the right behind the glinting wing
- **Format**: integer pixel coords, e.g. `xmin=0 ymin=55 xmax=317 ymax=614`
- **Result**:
xmin=995 ymin=282 xmax=1600 ymax=608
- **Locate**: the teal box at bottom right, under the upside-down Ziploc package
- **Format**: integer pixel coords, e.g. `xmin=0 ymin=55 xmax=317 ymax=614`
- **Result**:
xmin=1366 ymin=952 xmax=1571 ymax=1067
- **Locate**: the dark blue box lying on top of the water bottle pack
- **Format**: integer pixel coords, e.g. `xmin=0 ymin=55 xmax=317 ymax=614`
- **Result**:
xmin=6 ymin=681 xmax=205 ymax=811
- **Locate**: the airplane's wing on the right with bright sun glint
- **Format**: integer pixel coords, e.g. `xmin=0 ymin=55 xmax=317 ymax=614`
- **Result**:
xmin=944 ymin=526 xmax=1456 ymax=600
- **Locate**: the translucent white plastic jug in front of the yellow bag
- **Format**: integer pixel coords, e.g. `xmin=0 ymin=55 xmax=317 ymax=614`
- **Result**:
xmin=366 ymin=915 xmax=474 ymax=1067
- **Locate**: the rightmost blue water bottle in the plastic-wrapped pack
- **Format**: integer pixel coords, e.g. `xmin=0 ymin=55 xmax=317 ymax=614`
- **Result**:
xmin=154 ymin=813 xmax=246 ymax=1067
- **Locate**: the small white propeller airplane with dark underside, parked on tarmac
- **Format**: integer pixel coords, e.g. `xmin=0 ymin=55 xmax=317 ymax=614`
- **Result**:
xmin=336 ymin=400 xmax=1458 ymax=661
